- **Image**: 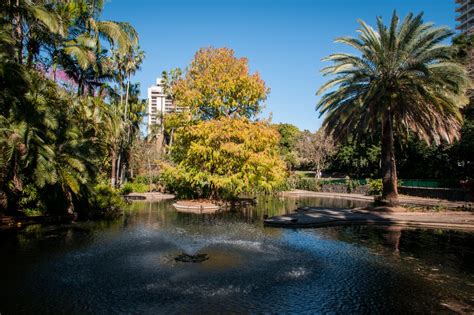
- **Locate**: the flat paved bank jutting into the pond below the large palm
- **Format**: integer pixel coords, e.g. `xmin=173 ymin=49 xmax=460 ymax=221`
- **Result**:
xmin=264 ymin=207 xmax=474 ymax=231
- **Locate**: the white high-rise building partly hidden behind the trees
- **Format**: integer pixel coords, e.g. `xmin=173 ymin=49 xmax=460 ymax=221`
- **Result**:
xmin=148 ymin=78 xmax=181 ymax=130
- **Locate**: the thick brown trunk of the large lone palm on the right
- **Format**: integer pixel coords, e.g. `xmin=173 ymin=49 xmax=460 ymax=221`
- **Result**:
xmin=382 ymin=113 xmax=399 ymax=206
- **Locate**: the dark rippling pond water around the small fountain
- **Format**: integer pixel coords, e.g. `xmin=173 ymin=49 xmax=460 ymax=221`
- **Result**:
xmin=0 ymin=197 xmax=474 ymax=315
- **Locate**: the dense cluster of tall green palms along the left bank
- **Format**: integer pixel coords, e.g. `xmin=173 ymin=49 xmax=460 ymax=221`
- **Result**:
xmin=0 ymin=0 xmax=145 ymax=213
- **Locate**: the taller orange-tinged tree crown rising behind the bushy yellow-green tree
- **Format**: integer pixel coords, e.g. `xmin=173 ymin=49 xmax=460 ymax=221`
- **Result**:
xmin=172 ymin=47 xmax=270 ymax=120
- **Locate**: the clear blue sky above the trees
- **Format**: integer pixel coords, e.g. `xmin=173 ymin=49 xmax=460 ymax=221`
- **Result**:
xmin=103 ymin=0 xmax=455 ymax=131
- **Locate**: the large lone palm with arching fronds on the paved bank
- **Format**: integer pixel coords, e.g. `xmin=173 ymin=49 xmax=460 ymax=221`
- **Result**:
xmin=317 ymin=12 xmax=469 ymax=205
